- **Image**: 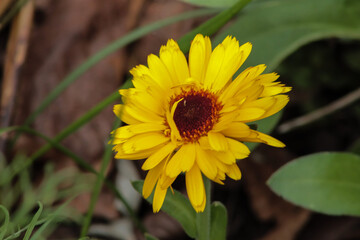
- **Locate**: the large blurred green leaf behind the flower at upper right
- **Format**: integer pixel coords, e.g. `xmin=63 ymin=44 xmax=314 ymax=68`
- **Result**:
xmin=214 ymin=0 xmax=360 ymax=71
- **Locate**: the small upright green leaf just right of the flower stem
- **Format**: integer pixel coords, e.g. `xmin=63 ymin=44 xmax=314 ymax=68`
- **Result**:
xmin=210 ymin=202 xmax=227 ymax=240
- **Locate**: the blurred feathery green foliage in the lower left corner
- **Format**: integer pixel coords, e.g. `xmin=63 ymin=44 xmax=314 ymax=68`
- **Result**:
xmin=0 ymin=154 xmax=92 ymax=239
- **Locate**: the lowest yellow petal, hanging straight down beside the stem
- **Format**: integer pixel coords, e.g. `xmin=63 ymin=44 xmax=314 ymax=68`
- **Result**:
xmin=185 ymin=164 xmax=206 ymax=212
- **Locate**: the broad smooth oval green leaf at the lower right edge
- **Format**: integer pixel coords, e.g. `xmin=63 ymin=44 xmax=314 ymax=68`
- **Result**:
xmin=268 ymin=152 xmax=360 ymax=216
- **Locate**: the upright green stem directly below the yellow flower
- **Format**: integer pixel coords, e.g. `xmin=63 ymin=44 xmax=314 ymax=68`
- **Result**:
xmin=196 ymin=176 xmax=211 ymax=240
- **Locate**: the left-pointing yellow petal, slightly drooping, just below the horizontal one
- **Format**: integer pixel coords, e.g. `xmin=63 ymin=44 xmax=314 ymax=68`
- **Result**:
xmin=122 ymin=132 xmax=170 ymax=154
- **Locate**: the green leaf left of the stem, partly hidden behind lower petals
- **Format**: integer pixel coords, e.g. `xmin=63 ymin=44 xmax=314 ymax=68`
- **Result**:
xmin=132 ymin=181 xmax=196 ymax=238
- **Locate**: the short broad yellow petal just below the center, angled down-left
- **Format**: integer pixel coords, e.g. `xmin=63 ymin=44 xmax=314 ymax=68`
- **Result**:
xmin=166 ymin=143 xmax=195 ymax=177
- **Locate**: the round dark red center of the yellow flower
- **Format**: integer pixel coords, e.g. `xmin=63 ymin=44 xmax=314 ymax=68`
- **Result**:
xmin=173 ymin=90 xmax=222 ymax=142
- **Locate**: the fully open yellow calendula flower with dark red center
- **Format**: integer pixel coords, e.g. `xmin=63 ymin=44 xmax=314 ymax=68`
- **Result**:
xmin=112 ymin=34 xmax=291 ymax=212
